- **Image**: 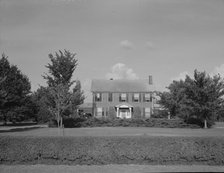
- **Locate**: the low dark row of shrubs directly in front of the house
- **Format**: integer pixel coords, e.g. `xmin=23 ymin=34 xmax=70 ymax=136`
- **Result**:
xmin=49 ymin=118 xmax=200 ymax=128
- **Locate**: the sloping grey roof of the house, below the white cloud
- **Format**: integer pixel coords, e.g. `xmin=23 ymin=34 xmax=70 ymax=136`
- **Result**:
xmin=91 ymin=79 xmax=153 ymax=92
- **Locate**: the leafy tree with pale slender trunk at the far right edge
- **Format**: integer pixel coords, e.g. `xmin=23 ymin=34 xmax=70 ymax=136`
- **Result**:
xmin=185 ymin=70 xmax=224 ymax=128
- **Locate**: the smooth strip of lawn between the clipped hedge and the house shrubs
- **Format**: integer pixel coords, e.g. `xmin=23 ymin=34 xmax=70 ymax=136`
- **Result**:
xmin=0 ymin=127 xmax=224 ymax=137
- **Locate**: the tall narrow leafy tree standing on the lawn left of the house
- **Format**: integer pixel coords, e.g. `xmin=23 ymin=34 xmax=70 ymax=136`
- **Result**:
xmin=43 ymin=50 xmax=84 ymax=126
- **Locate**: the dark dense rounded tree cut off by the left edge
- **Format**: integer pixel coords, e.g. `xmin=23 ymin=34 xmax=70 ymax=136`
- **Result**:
xmin=0 ymin=54 xmax=31 ymax=124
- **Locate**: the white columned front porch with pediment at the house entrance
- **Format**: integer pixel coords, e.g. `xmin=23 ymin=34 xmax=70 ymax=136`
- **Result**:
xmin=115 ymin=103 xmax=133 ymax=119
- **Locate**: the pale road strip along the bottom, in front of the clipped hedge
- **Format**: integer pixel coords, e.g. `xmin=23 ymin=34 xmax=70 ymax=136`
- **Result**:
xmin=0 ymin=165 xmax=224 ymax=173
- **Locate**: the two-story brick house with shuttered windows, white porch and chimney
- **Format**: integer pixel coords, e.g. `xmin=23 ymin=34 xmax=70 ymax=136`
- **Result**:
xmin=91 ymin=76 xmax=153 ymax=118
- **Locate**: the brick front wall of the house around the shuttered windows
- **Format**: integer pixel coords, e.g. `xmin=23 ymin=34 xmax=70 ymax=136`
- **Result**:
xmin=93 ymin=92 xmax=153 ymax=117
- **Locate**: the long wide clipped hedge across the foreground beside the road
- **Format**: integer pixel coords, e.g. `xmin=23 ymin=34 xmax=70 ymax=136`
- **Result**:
xmin=0 ymin=136 xmax=224 ymax=165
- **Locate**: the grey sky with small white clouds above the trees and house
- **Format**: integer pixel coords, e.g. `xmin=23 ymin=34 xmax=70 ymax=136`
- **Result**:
xmin=0 ymin=0 xmax=224 ymax=101
